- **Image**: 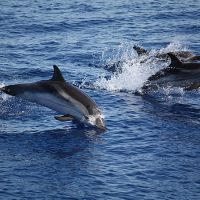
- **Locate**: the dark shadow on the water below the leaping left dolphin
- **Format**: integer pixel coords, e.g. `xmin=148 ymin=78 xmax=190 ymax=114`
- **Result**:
xmin=0 ymin=128 xmax=103 ymax=160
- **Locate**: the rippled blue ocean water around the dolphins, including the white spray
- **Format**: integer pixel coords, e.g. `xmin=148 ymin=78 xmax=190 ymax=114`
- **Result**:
xmin=0 ymin=0 xmax=200 ymax=200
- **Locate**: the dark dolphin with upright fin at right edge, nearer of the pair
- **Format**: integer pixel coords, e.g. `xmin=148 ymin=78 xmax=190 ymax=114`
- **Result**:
xmin=142 ymin=53 xmax=200 ymax=93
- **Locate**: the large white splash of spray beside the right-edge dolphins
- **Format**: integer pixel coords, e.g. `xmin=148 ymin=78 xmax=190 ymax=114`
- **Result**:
xmin=95 ymin=42 xmax=188 ymax=92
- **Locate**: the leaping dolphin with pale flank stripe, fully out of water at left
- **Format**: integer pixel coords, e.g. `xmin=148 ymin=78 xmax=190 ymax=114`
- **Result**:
xmin=0 ymin=65 xmax=106 ymax=130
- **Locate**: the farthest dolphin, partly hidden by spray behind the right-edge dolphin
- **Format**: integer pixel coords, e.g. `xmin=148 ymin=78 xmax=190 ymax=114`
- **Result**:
xmin=133 ymin=45 xmax=200 ymax=62
